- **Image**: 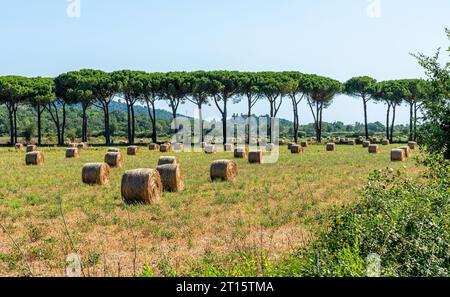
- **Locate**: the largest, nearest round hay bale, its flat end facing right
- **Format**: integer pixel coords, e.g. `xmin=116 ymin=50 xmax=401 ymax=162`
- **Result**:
xmin=121 ymin=169 xmax=163 ymax=204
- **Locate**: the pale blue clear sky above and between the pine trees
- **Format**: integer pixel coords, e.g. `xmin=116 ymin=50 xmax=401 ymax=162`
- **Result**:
xmin=0 ymin=0 xmax=450 ymax=123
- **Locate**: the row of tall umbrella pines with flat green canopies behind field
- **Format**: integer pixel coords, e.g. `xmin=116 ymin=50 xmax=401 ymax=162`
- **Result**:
xmin=0 ymin=69 xmax=433 ymax=145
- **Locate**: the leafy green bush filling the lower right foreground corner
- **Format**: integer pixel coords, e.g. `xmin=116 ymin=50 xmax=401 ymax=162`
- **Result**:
xmin=278 ymin=151 xmax=450 ymax=276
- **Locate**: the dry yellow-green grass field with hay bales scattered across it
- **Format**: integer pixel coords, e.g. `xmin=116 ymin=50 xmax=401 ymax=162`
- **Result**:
xmin=0 ymin=145 xmax=420 ymax=276
